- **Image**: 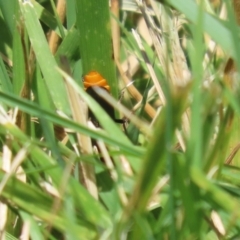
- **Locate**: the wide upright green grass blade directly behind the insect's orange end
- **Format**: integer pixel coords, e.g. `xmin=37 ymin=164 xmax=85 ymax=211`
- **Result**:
xmin=76 ymin=0 xmax=118 ymax=98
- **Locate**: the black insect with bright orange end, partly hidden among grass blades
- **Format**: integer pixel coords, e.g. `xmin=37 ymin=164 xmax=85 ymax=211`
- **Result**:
xmin=83 ymin=71 xmax=125 ymax=126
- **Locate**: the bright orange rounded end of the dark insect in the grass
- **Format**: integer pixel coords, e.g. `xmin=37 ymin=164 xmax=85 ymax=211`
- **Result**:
xmin=83 ymin=71 xmax=110 ymax=92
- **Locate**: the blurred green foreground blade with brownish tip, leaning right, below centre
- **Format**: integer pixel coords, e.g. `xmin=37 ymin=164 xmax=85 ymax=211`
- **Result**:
xmin=126 ymin=87 xmax=186 ymax=215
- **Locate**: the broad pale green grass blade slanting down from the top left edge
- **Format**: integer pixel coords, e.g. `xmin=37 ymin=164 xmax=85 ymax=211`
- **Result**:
xmin=20 ymin=1 xmax=69 ymax=113
